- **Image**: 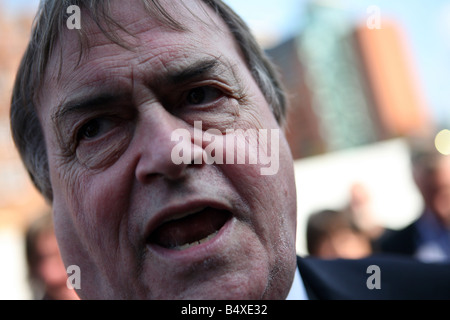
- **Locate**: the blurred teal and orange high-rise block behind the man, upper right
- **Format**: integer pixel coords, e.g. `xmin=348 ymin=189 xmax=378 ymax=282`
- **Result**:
xmin=267 ymin=2 xmax=430 ymax=159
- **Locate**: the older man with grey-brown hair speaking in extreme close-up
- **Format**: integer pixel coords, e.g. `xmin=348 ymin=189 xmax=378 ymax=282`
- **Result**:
xmin=11 ymin=0 xmax=448 ymax=299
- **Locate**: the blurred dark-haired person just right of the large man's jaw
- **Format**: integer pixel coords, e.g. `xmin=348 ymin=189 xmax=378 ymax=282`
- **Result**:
xmin=306 ymin=210 xmax=372 ymax=259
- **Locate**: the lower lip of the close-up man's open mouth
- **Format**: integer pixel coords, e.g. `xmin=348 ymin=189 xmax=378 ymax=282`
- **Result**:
xmin=147 ymin=217 xmax=235 ymax=263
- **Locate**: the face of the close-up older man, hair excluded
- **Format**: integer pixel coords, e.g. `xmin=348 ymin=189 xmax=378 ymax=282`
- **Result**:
xmin=38 ymin=1 xmax=296 ymax=299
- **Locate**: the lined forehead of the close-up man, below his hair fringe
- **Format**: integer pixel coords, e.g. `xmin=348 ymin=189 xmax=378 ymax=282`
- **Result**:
xmin=41 ymin=0 xmax=242 ymax=99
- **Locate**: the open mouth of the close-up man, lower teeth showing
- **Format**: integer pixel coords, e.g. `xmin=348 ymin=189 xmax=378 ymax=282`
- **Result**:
xmin=147 ymin=207 xmax=231 ymax=250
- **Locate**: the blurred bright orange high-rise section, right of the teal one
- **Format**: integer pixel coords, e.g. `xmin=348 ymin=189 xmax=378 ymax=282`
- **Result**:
xmin=353 ymin=21 xmax=431 ymax=137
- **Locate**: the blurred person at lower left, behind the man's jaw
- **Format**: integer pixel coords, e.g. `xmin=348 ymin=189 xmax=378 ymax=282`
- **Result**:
xmin=25 ymin=213 xmax=78 ymax=300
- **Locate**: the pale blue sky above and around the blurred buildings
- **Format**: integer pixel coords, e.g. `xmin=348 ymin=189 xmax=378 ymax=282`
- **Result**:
xmin=0 ymin=0 xmax=450 ymax=127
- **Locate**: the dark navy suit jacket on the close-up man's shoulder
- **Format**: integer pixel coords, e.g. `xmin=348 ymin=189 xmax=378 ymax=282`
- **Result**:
xmin=297 ymin=255 xmax=450 ymax=300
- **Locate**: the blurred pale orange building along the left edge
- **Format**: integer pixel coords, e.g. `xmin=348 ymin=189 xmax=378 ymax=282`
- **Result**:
xmin=0 ymin=4 xmax=46 ymax=228
